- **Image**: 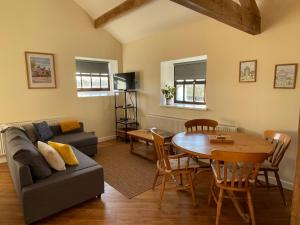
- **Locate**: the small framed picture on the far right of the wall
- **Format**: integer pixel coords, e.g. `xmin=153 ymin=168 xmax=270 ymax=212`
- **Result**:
xmin=274 ymin=63 xmax=298 ymax=89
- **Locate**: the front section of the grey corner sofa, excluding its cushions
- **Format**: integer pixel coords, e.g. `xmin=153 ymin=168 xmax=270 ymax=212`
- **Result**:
xmin=5 ymin=128 xmax=104 ymax=224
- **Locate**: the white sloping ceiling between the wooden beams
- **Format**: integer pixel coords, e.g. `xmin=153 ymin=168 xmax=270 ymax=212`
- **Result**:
xmin=74 ymin=0 xmax=263 ymax=43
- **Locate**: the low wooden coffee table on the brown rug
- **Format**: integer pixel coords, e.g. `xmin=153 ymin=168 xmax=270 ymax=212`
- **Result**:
xmin=127 ymin=129 xmax=174 ymax=162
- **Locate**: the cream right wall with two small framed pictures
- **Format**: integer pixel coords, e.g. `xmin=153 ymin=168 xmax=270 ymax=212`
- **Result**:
xmin=123 ymin=0 xmax=300 ymax=186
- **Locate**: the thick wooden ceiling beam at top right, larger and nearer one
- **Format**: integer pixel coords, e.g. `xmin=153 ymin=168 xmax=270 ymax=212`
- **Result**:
xmin=171 ymin=0 xmax=261 ymax=35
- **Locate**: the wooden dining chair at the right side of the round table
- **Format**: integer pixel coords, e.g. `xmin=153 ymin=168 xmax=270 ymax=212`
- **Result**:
xmin=258 ymin=130 xmax=291 ymax=205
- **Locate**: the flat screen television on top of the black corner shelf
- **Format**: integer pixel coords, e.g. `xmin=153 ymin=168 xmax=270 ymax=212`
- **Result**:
xmin=113 ymin=72 xmax=137 ymax=91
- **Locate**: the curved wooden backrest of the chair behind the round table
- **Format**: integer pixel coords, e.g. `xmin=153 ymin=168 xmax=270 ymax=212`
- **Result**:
xmin=184 ymin=119 xmax=218 ymax=132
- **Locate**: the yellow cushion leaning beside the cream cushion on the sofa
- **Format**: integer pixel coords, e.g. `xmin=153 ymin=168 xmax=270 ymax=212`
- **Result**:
xmin=48 ymin=141 xmax=79 ymax=166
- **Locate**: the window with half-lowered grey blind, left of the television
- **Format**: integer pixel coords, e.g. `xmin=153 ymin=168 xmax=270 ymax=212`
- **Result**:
xmin=76 ymin=59 xmax=110 ymax=91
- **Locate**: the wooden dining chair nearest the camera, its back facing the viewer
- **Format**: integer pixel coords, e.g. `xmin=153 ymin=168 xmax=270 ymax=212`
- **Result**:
xmin=208 ymin=150 xmax=268 ymax=225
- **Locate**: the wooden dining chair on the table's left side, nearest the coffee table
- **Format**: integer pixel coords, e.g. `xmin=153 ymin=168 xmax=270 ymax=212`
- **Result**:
xmin=151 ymin=130 xmax=199 ymax=205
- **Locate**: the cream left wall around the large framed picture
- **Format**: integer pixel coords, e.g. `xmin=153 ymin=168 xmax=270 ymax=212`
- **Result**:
xmin=0 ymin=0 xmax=122 ymax=137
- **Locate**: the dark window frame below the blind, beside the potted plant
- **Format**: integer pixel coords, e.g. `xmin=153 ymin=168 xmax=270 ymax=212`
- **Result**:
xmin=174 ymin=78 xmax=206 ymax=105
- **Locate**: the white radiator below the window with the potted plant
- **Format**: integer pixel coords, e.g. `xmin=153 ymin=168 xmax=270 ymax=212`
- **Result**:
xmin=145 ymin=114 xmax=238 ymax=133
